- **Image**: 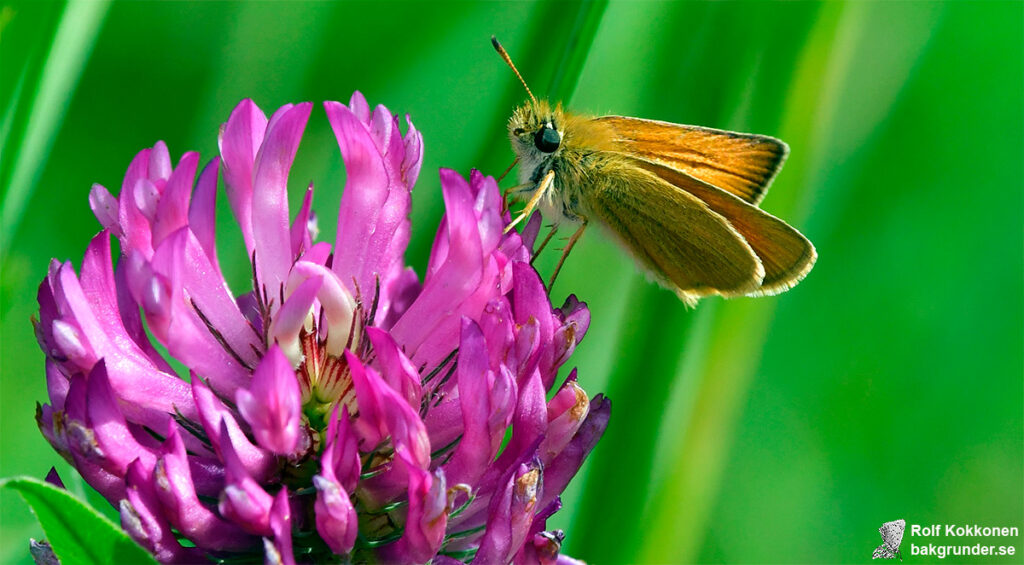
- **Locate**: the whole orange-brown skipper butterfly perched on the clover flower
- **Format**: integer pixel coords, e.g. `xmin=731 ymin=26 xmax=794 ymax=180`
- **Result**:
xmin=492 ymin=37 xmax=817 ymax=305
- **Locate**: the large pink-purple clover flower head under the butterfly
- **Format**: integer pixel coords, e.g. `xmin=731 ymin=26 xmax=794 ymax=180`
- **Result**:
xmin=36 ymin=92 xmax=610 ymax=563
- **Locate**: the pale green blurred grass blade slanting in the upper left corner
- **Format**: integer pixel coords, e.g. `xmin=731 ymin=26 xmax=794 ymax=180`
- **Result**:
xmin=0 ymin=0 xmax=111 ymax=257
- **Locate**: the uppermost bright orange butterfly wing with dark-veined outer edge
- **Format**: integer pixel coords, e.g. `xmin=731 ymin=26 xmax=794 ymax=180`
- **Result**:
xmin=594 ymin=116 xmax=790 ymax=205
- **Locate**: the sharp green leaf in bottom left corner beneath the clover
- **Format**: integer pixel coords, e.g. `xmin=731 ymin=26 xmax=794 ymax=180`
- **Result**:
xmin=0 ymin=477 xmax=156 ymax=565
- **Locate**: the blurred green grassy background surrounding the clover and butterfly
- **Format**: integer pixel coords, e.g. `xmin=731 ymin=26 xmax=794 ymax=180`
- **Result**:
xmin=0 ymin=1 xmax=1024 ymax=563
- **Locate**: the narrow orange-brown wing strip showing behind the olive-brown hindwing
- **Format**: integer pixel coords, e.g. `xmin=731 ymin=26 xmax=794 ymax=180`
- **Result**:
xmin=631 ymin=158 xmax=817 ymax=295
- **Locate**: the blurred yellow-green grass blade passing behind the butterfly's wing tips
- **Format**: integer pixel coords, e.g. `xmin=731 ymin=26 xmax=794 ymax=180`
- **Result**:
xmin=638 ymin=3 xmax=942 ymax=562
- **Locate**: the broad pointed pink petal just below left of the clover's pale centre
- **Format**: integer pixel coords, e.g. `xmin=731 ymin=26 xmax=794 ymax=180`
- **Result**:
xmin=234 ymin=345 xmax=302 ymax=455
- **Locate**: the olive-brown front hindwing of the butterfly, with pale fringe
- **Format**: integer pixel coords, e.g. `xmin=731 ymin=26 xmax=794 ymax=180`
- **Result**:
xmin=587 ymin=163 xmax=765 ymax=304
